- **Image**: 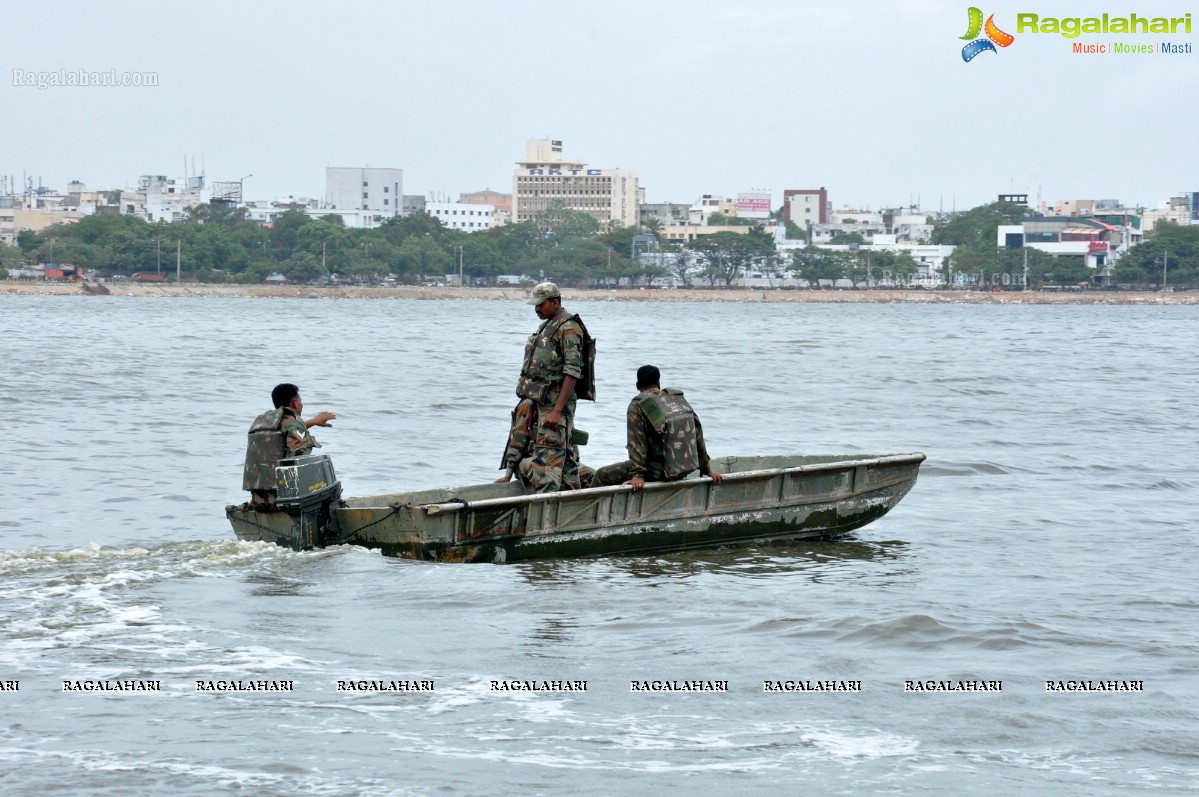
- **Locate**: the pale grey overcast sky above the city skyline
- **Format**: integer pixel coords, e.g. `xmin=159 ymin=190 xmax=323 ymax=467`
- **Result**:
xmin=0 ymin=0 xmax=1199 ymax=210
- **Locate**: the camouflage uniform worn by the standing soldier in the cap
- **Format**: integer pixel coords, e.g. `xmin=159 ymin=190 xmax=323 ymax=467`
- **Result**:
xmin=517 ymin=313 xmax=584 ymax=493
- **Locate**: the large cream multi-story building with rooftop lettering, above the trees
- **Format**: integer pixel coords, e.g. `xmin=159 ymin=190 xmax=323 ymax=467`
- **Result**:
xmin=512 ymin=138 xmax=640 ymax=227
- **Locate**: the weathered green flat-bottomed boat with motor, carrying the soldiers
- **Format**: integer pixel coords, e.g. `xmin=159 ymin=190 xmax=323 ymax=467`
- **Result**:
xmin=225 ymin=453 xmax=924 ymax=562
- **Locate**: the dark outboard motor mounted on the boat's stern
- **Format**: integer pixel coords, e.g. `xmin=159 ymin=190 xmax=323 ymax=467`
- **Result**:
xmin=275 ymin=454 xmax=342 ymax=550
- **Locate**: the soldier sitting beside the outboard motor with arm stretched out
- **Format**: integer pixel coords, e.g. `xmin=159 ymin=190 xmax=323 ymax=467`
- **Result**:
xmin=241 ymin=382 xmax=337 ymax=512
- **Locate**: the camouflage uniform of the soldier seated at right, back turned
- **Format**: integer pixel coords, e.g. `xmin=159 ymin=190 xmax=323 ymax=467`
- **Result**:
xmin=591 ymin=387 xmax=711 ymax=487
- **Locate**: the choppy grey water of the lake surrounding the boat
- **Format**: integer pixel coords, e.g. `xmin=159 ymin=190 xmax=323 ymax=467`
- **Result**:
xmin=0 ymin=296 xmax=1199 ymax=796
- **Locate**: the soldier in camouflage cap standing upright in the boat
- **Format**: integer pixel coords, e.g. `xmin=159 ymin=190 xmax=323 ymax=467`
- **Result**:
xmin=517 ymin=283 xmax=595 ymax=493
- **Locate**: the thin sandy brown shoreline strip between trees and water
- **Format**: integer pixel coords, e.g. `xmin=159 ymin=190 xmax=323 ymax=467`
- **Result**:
xmin=0 ymin=280 xmax=1199 ymax=304
